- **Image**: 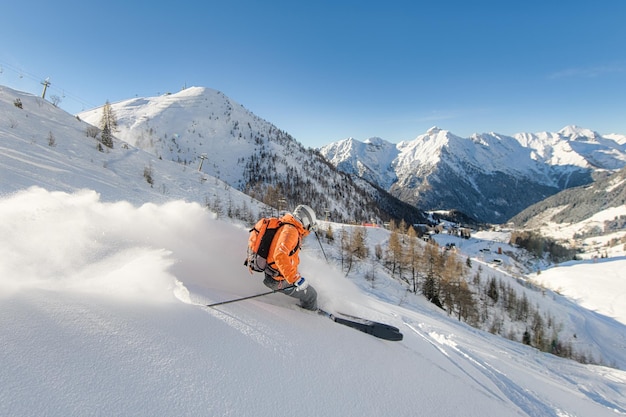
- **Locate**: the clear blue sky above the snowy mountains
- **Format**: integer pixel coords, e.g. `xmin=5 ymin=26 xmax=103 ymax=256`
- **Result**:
xmin=0 ymin=0 xmax=626 ymax=147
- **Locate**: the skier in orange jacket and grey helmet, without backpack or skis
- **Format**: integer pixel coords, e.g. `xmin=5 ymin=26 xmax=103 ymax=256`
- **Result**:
xmin=263 ymin=204 xmax=317 ymax=311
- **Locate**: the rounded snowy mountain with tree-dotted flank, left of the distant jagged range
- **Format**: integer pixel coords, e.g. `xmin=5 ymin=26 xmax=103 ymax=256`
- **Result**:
xmin=79 ymin=87 xmax=422 ymax=226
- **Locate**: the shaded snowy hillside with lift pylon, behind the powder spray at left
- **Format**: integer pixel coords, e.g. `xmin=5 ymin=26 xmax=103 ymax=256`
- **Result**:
xmin=0 ymin=86 xmax=254 ymax=209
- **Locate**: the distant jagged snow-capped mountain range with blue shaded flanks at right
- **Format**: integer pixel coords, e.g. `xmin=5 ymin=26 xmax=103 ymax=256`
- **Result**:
xmin=321 ymin=126 xmax=626 ymax=223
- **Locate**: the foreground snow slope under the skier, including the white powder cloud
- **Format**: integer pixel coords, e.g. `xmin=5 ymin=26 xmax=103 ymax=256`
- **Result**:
xmin=0 ymin=188 xmax=626 ymax=417
